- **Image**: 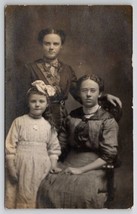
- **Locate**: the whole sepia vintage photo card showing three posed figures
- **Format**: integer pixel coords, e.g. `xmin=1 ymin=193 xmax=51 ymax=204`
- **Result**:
xmin=4 ymin=5 xmax=133 ymax=209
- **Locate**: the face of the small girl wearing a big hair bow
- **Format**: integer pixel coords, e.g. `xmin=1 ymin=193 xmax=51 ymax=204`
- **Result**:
xmin=29 ymin=94 xmax=48 ymax=117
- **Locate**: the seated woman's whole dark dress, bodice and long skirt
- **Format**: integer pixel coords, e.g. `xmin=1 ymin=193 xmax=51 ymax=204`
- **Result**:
xmin=37 ymin=108 xmax=118 ymax=208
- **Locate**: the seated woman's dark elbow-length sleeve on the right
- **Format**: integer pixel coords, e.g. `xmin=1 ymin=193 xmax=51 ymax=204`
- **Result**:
xmin=100 ymin=118 xmax=119 ymax=163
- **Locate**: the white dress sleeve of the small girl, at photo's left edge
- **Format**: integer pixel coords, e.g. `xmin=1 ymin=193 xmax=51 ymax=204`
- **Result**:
xmin=6 ymin=119 xmax=19 ymax=159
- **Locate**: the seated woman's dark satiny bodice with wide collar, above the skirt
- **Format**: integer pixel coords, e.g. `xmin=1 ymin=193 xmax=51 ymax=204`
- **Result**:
xmin=59 ymin=108 xmax=118 ymax=161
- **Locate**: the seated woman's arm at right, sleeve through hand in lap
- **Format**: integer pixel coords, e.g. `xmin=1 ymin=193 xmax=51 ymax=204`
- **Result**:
xmin=65 ymin=118 xmax=118 ymax=174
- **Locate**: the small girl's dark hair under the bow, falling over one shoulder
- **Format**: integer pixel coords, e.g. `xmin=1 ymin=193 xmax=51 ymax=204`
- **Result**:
xmin=27 ymin=87 xmax=55 ymax=128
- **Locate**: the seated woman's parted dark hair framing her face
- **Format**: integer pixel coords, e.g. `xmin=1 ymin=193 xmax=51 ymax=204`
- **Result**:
xmin=77 ymin=74 xmax=104 ymax=103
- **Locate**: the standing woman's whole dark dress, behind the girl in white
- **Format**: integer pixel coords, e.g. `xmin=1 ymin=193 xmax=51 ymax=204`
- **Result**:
xmin=17 ymin=59 xmax=77 ymax=129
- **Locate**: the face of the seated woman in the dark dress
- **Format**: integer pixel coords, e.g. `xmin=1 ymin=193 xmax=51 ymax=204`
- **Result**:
xmin=80 ymin=79 xmax=100 ymax=108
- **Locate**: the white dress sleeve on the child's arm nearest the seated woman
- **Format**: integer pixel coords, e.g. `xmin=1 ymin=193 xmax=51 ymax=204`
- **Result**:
xmin=48 ymin=128 xmax=61 ymax=160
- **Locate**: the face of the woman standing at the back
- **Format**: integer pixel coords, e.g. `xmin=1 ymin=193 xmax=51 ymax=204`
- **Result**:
xmin=42 ymin=34 xmax=62 ymax=60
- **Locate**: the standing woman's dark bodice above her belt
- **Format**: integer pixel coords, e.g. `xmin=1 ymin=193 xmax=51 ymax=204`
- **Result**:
xmin=26 ymin=59 xmax=77 ymax=103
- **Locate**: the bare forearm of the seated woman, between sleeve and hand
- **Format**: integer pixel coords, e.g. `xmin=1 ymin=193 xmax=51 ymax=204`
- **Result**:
xmin=80 ymin=158 xmax=106 ymax=173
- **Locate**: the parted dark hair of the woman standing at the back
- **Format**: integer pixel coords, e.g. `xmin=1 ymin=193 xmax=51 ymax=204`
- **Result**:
xmin=38 ymin=28 xmax=66 ymax=45
